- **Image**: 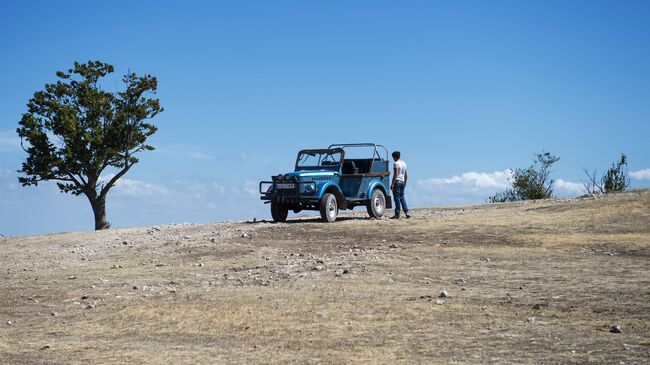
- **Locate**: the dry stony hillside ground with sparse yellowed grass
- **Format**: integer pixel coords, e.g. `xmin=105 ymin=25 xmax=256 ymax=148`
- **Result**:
xmin=0 ymin=190 xmax=650 ymax=364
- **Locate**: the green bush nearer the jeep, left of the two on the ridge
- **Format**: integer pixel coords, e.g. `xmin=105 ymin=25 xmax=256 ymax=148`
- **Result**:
xmin=488 ymin=151 xmax=560 ymax=203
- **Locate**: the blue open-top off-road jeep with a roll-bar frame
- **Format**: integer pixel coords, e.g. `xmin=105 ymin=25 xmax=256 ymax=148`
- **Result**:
xmin=260 ymin=143 xmax=392 ymax=223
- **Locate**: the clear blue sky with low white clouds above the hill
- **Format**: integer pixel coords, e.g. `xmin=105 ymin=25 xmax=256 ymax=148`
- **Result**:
xmin=0 ymin=1 xmax=650 ymax=236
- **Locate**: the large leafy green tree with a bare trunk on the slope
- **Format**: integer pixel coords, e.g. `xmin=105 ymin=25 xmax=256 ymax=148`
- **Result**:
xmin=17 ymin=61 xmax=163 ymax=230
